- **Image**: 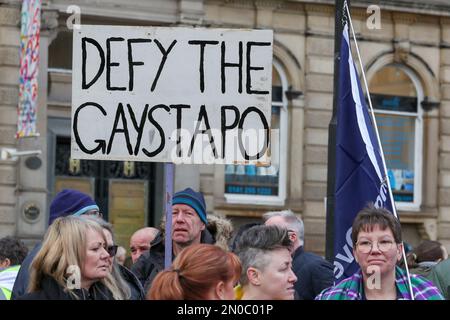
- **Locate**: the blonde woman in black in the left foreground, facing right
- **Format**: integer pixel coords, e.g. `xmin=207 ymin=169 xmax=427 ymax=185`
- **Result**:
xmin=19 ymin=216 xmax=129 ymax=300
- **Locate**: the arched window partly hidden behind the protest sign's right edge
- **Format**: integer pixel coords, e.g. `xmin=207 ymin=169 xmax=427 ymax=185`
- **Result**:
xmin=225 ymin=61 xmax=288 ymax=205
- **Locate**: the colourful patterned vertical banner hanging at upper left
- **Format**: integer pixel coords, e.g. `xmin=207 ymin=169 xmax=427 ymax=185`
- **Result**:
xmin=16 ymin=0 xmax=41 ymax=138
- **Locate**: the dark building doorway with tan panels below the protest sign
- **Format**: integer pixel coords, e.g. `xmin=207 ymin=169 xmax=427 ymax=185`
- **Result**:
xmin=51 ymin=137 xmax=156 ymax=248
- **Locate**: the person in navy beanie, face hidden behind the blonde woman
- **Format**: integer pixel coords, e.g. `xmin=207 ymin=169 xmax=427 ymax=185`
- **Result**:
xmin=11 ymin=189 xmax=102 ymax=300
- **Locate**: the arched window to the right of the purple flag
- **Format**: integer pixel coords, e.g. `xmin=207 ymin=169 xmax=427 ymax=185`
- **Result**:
xmin=370 ymin=64 xmax=423 ymax=210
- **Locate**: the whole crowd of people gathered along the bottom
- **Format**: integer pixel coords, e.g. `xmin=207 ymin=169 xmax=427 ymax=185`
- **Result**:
xmin=0 ymin=188 xmax=450 ymax=300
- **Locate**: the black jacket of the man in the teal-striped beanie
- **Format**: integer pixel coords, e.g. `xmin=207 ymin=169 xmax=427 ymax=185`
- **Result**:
xmin=131 ymin=228 xmax=215 ymax=292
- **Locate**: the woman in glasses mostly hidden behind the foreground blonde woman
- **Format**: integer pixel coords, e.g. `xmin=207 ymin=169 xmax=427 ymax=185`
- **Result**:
xmin=90 ymin=217 xmax=145 ymax=300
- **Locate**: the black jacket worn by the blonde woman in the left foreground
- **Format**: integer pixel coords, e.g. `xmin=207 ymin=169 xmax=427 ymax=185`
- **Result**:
xmin=16 ymin=277 xmax=114 ymax=300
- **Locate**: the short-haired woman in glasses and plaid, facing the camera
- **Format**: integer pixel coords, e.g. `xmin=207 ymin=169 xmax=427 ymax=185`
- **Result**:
xmin=316 ymin=206 xmax=443 ymax=300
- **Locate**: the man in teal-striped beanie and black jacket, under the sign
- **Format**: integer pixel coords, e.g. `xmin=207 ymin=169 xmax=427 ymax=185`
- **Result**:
xmin=131 ymin=188 xmax=215 ymax=292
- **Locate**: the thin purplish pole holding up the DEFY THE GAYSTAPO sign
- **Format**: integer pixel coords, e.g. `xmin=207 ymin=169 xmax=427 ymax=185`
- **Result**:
xmin=164 ymin=163 xmax=174 ymax=269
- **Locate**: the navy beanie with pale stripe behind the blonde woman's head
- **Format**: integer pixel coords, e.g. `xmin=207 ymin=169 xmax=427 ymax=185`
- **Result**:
xmin=48 ymin=189 xmax=99 ymax=225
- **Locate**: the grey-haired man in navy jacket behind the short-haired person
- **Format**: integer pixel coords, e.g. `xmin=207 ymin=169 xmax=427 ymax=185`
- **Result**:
xmin=263 ymin=210 xmax=334 ymax=300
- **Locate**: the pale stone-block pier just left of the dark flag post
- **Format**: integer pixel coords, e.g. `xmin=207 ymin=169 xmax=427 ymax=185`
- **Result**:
xmin=303 ymin=5 xmax=334 ymax=255
